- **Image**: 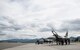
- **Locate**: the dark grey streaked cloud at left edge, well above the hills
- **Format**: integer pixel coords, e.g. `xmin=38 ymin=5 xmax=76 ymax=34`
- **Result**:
xmin=0 ymin=16 xmax=21 ymax=30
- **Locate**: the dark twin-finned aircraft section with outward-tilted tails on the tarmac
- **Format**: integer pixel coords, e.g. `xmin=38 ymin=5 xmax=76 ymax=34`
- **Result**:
xmin=52 ymin=31 xmax=70 ymax=45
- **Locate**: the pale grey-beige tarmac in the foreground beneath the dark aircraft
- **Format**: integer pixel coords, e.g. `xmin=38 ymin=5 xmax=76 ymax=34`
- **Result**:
xmin=3 ymin=43 xmax=80 ymax=50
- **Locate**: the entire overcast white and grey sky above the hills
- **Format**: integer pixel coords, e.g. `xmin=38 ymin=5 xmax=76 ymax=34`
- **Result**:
xmin=0 ymin=0 xmax=80 ymax=39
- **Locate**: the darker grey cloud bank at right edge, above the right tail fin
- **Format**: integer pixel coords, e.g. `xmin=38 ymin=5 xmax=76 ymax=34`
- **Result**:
xmin=60 ymin=19 xmax=80 ymax=31
